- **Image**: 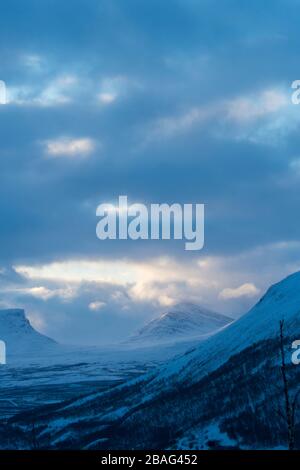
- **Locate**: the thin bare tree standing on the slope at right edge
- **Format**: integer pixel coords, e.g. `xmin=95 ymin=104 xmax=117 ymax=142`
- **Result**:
xmin=279 ymin=320 xmax=300 ymax=450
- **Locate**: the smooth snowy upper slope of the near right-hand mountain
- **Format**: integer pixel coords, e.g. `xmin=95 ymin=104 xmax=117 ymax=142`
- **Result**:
xmin=155 ymin=272 xmax=300 ymax=388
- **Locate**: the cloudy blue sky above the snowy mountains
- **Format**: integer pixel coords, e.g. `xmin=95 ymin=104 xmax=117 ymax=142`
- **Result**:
xmin=0 ymin=0 xmax=300 ymax=344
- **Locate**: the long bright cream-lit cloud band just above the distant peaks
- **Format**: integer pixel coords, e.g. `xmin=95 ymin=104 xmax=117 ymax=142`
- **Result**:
xmin=14 ymin=258 xmax=215 ymax=306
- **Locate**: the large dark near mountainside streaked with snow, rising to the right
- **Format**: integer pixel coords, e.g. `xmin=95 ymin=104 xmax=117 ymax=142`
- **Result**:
xmin=7 ymin=272 xmax=300 ymax=449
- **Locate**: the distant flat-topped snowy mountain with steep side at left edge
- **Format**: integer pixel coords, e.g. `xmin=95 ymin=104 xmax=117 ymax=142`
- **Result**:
xmin=0 ymin=309 xmax=57 ymax=358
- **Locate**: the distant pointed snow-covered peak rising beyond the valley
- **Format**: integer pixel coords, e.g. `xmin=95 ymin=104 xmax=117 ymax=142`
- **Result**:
xmin=130 ymin=302 xmax=233 ymax=345
